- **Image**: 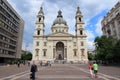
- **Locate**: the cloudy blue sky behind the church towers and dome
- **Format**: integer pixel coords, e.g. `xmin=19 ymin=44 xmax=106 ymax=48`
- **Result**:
xmin=7 ymin=0 xmax=119 ymax=51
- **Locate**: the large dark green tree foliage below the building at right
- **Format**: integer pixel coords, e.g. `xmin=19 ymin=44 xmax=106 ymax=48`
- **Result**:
xmin=94 ymin=36 xmax=120 ymax=61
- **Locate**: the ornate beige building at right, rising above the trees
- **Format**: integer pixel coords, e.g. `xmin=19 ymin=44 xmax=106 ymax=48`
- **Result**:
xmin=101 ymin=1 xmax=120 ymax=39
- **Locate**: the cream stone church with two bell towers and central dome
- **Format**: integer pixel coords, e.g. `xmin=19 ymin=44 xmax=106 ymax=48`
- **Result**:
xmin=32 ymin=7 xmax=88 ymax=62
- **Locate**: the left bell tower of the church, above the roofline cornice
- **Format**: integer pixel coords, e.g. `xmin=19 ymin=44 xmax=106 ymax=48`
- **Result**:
xmin=34 ymin=7 xmax=44 ymax=36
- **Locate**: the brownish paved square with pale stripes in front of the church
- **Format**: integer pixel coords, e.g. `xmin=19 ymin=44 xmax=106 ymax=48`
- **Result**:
xmin=0 ymin=64 xmax=120 ymax=80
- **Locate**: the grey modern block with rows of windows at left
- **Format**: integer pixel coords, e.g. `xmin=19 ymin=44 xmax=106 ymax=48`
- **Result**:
xmin=0 ymin=0 xmax=24 ymax=63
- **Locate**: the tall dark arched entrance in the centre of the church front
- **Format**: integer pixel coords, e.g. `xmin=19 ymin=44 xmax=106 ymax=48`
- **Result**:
xmin=56 ymin=42 xmax=64 ymax=60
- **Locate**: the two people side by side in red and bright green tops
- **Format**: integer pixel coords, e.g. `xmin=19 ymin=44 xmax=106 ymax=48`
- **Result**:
xmin=88 ymin=62 xmax=98 ymax=78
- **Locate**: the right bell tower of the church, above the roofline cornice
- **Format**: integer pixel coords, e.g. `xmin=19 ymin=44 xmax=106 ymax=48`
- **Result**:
xmin=75 ymin=7 xmax=85 ymax=36
